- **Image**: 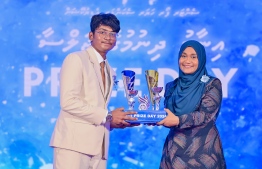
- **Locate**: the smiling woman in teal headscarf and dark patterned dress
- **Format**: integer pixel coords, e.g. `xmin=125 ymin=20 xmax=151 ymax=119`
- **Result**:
xmin=158 ymin=40 xmax=226 ymax=169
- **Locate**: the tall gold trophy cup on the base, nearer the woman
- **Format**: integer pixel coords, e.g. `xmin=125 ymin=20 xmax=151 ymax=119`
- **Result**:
xmin=145 ymin=70 xmax=163 ymax=111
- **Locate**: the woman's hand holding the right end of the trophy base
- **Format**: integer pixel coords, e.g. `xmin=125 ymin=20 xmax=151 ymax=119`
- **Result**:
xmin=157 ymin=109 xmax=179 ymax=127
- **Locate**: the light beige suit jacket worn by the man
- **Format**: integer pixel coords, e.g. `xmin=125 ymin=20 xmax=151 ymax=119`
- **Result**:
xmin=50 ymin=46 xmax=115 ymax=159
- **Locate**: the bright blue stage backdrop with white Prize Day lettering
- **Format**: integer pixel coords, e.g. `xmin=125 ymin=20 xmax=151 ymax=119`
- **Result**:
xmin=0 ymin=0 xmax=262 ymax=169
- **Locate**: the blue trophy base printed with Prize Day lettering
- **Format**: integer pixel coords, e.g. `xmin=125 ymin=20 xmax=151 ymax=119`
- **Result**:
xmin=126 ymin=110 xmax=167 ymax=124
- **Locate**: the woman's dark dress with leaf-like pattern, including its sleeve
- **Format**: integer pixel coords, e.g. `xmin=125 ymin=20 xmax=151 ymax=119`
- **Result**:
xmin=159 ymin=78 xmax=226 ymax=169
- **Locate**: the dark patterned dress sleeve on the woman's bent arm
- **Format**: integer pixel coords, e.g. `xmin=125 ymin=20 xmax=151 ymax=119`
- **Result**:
xmin=178 ymin=79 xmax=222 ymax=129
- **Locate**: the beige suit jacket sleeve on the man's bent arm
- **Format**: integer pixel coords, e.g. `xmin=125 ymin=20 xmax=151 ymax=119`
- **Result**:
xmin=60 ymin=53 xmax=107 ymax=125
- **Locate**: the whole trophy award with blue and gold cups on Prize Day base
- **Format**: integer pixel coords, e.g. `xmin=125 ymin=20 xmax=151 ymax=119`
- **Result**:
xmin=122 ymin=70 xmax=166 ymax=124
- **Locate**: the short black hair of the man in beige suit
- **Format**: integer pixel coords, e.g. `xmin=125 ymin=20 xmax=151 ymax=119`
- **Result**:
xmin=90 ymin=13 xmax=120 ymax=33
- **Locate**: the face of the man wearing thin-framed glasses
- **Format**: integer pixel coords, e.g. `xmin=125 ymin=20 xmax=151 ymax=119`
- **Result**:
xmin=89 ymin=25 xmax=116 ymax=59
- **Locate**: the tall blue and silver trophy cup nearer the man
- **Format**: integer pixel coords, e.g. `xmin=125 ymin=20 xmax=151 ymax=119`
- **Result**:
xmin=122 ymin=70 xmax=138 ymax=110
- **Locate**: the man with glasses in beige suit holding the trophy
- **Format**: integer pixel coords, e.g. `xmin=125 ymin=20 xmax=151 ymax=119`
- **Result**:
xmin=50 ymin=13 xmax=136 ymax=169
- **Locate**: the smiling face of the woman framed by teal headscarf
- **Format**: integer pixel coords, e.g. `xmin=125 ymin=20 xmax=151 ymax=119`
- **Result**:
xmin=179 ymin=47 xmax=198 ymax=74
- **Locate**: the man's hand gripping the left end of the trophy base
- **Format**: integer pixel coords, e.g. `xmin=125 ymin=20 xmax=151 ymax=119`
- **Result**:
xmin=110 ymin=107 xmax=140 ymax=128
